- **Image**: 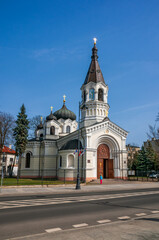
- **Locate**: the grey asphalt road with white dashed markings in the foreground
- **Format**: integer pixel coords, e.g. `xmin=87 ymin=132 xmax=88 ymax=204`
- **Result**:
xmin=0 ymin=188 xmax=159 ymax=240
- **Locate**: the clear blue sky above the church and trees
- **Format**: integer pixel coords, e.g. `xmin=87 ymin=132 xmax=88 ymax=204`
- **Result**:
xmin=0 ymin=0 xmax=159 ymax=145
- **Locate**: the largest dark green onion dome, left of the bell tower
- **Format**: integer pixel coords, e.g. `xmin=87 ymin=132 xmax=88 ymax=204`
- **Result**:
xmin=54 ymin=102 xmax=76 ymax=120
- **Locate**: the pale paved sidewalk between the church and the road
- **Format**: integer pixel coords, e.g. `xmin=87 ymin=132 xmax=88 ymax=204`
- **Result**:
xmin=0 ymin=180 xmax=159 ymax=197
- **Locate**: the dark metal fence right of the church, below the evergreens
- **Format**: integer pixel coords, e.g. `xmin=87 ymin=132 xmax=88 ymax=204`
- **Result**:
xmin=128 ymin=170 xmax=159 ymax=182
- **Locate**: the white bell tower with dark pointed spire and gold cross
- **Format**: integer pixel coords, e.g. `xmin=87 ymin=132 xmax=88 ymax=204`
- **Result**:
xmin=81 ymin=38 xmax=109 ymax=127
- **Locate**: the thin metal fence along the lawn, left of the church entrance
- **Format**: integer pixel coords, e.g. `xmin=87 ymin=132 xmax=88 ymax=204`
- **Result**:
xmin=0 ymin=168 xmax=85 ymax=186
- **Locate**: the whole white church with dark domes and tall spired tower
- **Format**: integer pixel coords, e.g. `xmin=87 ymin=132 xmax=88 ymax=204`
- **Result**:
xmin=21 ymin=39 xmax=128 ymax=181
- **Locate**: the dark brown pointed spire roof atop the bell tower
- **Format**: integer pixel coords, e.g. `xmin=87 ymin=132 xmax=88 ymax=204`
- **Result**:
xmin=84 ymin=43 xmax=105 ymax=84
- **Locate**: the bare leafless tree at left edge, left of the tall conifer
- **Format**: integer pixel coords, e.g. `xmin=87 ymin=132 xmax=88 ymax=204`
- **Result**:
xmin=0 ymin=112 xmax=15 ymax=157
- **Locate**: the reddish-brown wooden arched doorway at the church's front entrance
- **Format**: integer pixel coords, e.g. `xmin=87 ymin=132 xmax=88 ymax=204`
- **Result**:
xmin=97 ymin=144 xmax=114 ymax=178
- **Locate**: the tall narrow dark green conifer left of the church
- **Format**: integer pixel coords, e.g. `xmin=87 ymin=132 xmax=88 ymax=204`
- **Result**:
xmin=13 ymin=104 xmax=29 ymax=179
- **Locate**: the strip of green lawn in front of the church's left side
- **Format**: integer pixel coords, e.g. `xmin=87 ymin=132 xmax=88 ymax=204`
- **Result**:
xmin=3 ymin=178 xmax=75 ymax=186
